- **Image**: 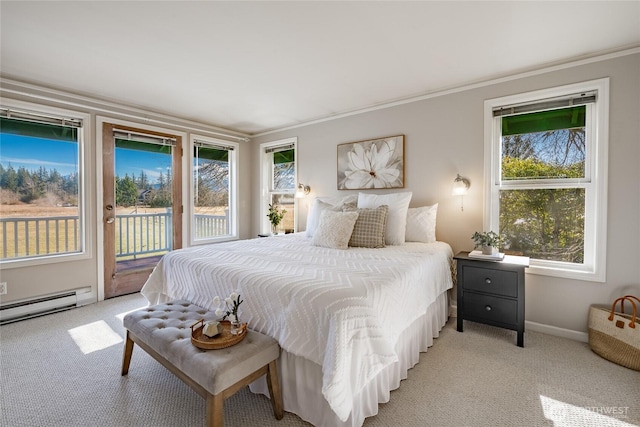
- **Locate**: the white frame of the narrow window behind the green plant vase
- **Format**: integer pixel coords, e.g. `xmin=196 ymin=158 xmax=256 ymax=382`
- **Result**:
xmin=259 ymin=137 xmax=298 ymax=233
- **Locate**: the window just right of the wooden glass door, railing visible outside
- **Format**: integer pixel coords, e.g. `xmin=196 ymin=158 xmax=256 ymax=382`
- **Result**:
xmin=191 ymin=137 xmax=238 ymax=243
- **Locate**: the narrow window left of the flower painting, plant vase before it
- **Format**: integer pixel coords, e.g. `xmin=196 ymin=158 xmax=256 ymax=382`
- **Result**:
xmin=260 ymin=138 xmax=297 ymax=233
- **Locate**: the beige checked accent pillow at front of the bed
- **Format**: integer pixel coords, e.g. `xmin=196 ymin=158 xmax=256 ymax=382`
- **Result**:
xmin=344 ymin=205 xmax=389 ymax=248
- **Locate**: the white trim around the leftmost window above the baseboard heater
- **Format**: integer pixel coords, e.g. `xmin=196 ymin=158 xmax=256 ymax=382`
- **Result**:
xmin=0 ymin=98 xmax=93 ymax=270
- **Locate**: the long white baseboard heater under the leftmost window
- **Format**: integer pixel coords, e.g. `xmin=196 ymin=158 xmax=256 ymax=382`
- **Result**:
xmin=0 ymin=289 xmax=85 ymax=325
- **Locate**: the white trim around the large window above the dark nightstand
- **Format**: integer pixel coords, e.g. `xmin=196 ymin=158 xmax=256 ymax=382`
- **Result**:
xmin=484 ymin=78 xmax=609 ymax=282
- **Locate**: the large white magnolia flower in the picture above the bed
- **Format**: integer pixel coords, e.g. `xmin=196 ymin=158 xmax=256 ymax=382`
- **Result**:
xmin=344 ymin=139 xmax=400 ymax=189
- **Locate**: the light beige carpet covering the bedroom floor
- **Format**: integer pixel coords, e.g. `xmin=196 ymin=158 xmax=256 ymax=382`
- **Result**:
xmin=0 ymin=294 xmax=640 ymax=427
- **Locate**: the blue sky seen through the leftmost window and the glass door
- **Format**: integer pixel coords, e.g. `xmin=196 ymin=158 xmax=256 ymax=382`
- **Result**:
xmin=0 ymin=133 xmax=171 ymax=183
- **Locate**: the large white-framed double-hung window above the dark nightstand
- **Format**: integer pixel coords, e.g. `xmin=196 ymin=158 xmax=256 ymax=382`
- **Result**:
xmin=485 ymin=79 xmax=609 ymax=281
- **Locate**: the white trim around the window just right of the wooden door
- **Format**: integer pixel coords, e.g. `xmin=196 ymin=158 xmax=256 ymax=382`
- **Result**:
xmin=187 ymin=134 xmax=240 ymax=246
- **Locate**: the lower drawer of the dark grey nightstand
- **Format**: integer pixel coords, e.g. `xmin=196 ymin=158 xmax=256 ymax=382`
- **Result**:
xmin=464 ymin=292 xmax=518 ymax=326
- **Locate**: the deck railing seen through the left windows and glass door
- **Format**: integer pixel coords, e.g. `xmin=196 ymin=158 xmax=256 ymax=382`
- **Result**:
xmin=0 ymin=212 xmax=228 ymax=259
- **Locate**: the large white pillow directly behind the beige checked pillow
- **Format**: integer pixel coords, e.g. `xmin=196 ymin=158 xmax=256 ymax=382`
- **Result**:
xmin=358 ymin=191 xmax=413 ymax=245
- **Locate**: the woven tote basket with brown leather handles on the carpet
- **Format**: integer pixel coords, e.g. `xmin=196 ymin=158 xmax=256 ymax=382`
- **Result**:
xmin=589 ymin=295 xmax=640 ymax=371
